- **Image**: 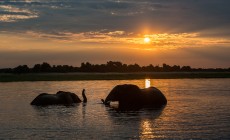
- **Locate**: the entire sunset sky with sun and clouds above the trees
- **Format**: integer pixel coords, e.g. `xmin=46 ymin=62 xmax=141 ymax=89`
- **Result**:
xmin=0 ymin=0 xmax=230 ymax=68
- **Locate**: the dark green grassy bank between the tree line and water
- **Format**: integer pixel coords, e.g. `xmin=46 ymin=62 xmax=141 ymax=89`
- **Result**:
xmin=0 ymin=72 xmax=230 ymax=82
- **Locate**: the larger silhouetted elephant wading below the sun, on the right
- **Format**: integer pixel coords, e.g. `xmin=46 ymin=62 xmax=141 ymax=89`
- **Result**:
xmin=102 ymin=84 xmax=167 ymax=109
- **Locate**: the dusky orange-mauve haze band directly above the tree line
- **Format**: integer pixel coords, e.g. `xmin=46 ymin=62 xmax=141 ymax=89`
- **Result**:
xmin=0 ymin=47 xmax=230 ymax=68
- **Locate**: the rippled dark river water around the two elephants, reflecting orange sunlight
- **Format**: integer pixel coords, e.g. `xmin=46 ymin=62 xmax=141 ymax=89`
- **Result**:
xmin=0 ymin=79 xmax=230 ymax=140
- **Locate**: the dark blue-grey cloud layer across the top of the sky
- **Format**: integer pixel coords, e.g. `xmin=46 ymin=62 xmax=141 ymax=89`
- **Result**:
xmin=0 ymin=0 xmax=230 ymax=36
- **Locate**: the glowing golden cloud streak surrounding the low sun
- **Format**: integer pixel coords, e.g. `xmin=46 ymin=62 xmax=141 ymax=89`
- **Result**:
xmin=20 ymin=30 xmax=230 ymax=50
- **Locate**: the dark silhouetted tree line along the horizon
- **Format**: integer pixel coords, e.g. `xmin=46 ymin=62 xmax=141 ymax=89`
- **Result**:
xmin=0 ymin=61 xmax=230 ymax=73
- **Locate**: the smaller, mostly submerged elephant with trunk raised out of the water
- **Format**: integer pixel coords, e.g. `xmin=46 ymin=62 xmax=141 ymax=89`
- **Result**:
xmin=30 ymin=89 xmax=87 ymax=106
